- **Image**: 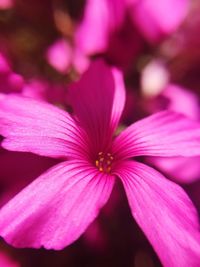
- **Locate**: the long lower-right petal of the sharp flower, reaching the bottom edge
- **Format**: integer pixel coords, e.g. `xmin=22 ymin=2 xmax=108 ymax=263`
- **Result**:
xmin=116 ymin=161 xmax=200 ymax=267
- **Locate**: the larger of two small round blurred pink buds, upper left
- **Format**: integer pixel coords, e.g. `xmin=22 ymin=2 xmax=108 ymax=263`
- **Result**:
xmin=46 ymin=39 xmax=72 ymax=74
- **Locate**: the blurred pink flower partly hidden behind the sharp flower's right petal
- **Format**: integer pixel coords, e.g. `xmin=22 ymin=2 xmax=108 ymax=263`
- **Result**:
xmin=146 ymin=84 xmax=200 ymax=183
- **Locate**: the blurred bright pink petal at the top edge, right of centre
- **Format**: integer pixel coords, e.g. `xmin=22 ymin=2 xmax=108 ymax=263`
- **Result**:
xmin=132 ymin=0 xmax=189 ymax=42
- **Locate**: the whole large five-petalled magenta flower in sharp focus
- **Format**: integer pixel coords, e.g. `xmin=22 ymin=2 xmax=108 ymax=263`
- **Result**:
xmin=0 ymin=61 xmax=200 ymax=267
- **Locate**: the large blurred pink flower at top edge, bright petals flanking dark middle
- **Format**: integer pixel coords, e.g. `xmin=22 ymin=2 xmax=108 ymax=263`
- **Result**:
xmin=75 ymin=0 xmax=188 ymax=69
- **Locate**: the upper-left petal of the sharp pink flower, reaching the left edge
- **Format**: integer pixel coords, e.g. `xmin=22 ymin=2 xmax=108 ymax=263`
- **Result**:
xmin=0 ymin=94 xmax=88 ymax=158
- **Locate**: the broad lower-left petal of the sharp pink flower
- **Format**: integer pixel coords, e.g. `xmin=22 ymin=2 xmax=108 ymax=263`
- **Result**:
xmin=0 ymin=161 xmax=114 ymax=249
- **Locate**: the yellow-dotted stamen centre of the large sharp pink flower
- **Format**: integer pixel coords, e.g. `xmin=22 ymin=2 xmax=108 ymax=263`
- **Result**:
xmin=95 ymin=152 xmax=114 ymax=173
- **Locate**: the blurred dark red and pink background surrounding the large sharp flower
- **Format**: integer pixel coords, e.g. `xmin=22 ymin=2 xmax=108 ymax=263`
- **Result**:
xmin=0 ymin=0 xmax=200 ymax=267
